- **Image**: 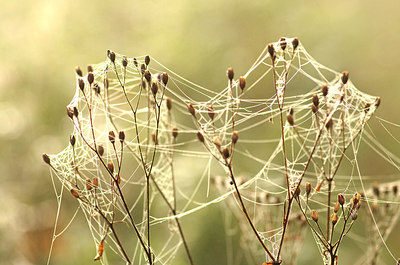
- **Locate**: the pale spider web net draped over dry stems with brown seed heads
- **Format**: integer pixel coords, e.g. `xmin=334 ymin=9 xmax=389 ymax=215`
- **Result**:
xmin=44 ymin=38 xmax=399 ymax=264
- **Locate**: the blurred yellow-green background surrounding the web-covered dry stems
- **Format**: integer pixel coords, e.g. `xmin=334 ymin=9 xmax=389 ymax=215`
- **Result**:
xmin=0 ymin=0 xmax=400 ymax=264
